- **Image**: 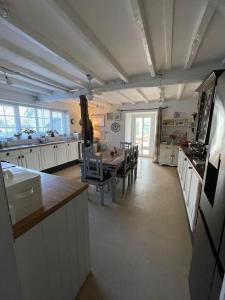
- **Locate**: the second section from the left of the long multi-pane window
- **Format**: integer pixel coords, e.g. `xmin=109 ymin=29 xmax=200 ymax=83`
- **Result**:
xmin=19 ymin=106 xmax=37 ymax=131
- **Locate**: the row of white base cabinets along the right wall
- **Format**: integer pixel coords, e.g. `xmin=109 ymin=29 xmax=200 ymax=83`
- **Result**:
xmin=177 ymin=149 xmax=202 ymax=231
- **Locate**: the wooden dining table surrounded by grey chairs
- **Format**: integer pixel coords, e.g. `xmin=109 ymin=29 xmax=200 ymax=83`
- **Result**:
xmin=80 ymin=149 xmax=125 ymax=202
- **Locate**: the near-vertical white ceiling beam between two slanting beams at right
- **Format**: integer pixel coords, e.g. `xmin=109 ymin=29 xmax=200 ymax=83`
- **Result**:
xmin=163 ymin=0 xmax=174 ymax=70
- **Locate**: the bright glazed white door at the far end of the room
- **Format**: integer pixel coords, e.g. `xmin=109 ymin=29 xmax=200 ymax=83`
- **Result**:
xmin=132 ymin=114 xmax=155 ymax=157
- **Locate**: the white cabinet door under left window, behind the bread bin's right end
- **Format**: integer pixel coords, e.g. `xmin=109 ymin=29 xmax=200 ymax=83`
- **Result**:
xmin=21 ymin=148 xmax=42 ymax=171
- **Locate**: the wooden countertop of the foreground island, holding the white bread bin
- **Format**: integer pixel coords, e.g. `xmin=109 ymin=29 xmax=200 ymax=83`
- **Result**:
xmin=13 ymin=172 xmax=88 ymax=239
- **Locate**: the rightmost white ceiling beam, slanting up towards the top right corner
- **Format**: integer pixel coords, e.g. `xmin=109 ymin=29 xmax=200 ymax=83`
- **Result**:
xmin=184 ymin=0 xmax=218 ymax=69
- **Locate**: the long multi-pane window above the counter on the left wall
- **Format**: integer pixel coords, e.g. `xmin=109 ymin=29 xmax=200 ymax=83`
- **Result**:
xmin=0 ymin=103 xmax=69 ymax=138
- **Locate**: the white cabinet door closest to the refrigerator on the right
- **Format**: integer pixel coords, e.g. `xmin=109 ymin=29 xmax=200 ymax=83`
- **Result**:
xmin=187 ymin=171 xmax=201 ymax=231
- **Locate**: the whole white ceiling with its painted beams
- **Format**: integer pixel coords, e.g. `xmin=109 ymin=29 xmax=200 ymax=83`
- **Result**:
xmin=0 ymin=0 xmax=225 ymax=104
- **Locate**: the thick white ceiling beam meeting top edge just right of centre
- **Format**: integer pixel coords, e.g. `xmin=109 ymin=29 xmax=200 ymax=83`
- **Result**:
xmin=130 ymin=0 xmax=156 ymax=77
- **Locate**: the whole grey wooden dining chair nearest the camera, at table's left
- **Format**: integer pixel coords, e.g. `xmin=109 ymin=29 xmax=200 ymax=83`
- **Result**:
xmin=81 ymin=147 xmax=111 ymax=205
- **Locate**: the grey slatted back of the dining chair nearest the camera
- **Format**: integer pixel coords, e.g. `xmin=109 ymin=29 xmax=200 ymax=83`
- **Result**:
xmin=83 ymin=147 xmax=103 ymax=181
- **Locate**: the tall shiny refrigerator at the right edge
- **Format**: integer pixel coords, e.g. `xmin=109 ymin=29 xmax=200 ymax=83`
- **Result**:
xmin=189 ymin=73 xmax=225 ymax=300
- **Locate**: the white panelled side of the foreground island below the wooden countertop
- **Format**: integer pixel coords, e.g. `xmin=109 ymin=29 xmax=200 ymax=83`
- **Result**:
xmin=15 ymin=191 xmax=90 ymax=300
